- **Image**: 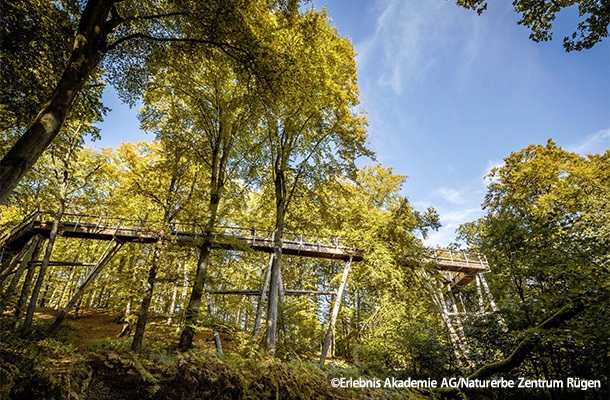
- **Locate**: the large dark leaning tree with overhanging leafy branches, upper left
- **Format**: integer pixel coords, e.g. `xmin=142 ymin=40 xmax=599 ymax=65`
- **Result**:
xmin=0 ymin=0 xmax=298 ymax=202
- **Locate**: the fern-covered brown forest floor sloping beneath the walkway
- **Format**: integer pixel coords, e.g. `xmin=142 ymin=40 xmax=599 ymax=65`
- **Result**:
xmin=0 ymin=308 xmax=434 ymax=400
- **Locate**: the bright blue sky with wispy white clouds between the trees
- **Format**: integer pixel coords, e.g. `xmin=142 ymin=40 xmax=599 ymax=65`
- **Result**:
xmin=96 ymin=0 xmax=610 ymax=245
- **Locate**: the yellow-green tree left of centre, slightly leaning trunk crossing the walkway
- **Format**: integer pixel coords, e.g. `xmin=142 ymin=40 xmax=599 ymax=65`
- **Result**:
xmin=141 ymin=48 xmax=256 ymax=351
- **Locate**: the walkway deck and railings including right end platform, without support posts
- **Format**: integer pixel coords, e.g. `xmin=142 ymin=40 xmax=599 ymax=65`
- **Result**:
xmin=0 ymin=212 xmax=489 ymax=291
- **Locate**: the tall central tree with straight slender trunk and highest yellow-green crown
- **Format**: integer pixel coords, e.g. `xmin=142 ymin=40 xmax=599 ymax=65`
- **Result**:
xmin=261 ymin=10 xmax=372 ymax=353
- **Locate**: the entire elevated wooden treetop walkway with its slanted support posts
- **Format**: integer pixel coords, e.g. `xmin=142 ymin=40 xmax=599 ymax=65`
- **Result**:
xmin=0 ymin=212 xmax=496 ymax=361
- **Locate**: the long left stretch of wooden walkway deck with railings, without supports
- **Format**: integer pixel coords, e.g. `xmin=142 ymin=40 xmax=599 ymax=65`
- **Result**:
xmin=0 ymin=213 xmax=364 ymax=261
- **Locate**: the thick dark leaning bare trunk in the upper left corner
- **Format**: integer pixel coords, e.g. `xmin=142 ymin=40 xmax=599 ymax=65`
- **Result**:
xmin=0 ymin=0 xmax=116 ymax=203
